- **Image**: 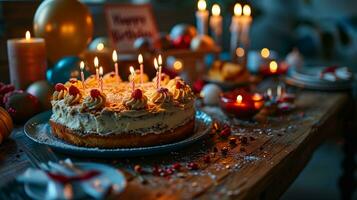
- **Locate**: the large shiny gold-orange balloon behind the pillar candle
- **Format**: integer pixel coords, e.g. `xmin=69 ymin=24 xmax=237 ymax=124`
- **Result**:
xmin=34 ymin=0 xmax=93 ymax=62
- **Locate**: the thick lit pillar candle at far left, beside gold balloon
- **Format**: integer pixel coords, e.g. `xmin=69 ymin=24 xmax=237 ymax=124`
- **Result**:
xmin=7 ymin=31 xmax=47 ymax=89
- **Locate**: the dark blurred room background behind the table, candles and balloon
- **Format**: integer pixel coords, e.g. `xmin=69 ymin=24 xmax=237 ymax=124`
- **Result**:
xmin=0 ymin=0 xmax=357 ymax=199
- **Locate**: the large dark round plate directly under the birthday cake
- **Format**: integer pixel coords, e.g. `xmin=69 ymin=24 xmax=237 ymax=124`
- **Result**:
xmin=24 ymin=111 xmax=212 ymax=157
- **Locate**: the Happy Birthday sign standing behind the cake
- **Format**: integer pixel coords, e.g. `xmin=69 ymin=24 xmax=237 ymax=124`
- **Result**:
xmin=105 ymin=4 xmax=158 ymax=52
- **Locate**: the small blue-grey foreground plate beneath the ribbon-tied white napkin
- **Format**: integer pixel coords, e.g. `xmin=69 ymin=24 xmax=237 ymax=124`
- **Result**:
xmin=25 ymin=163 xmax=126 ymax=200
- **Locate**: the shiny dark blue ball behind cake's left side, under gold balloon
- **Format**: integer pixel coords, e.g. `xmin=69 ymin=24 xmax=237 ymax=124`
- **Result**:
xmin=46 ymin=56 xmax=90 ymax=84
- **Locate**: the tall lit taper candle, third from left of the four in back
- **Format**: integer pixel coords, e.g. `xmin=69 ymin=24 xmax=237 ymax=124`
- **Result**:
xmin=230 ymin=3 xmax=243 ymax=52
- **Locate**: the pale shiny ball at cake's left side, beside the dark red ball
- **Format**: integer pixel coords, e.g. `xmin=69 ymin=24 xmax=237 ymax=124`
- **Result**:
xmin=26 ymin=81 xmax=54 ymax=110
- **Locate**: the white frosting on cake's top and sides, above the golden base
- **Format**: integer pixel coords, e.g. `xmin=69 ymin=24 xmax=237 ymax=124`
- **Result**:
xmin=51 ymin=75 xmax=195 ymax=135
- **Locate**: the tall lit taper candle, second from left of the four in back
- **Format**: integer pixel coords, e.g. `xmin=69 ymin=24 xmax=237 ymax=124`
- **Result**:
xmin=210 ymin=4 xmax=222 ymax=44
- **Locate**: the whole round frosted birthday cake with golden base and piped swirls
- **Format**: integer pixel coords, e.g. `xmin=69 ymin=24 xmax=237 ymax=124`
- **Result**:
xmin=50 ymin=74 xmax=195 ymax=148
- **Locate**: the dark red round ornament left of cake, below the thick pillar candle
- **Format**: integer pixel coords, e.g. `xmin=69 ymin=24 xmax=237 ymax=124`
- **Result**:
xmin=4 ymin=91 xmax=41 ymax=123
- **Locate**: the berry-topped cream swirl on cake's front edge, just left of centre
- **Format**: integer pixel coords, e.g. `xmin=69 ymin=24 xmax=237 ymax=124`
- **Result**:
xmin=82 ymin=89 xmax=106 ymax=111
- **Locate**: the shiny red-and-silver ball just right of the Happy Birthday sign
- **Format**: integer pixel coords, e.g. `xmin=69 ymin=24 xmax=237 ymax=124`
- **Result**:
xmin=170 ymin=24 xmax=197 ymax=49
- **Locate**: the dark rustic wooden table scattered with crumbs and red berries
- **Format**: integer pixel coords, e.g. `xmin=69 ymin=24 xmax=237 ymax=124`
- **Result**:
xmin=0 ymin=82 xmax=354 ymax=199
